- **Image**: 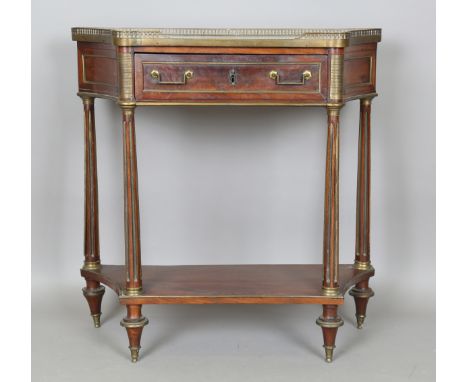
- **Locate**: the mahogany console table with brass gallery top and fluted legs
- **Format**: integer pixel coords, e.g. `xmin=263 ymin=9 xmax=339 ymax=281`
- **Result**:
xmin=72 ymin=28 xmax=381 ymax=362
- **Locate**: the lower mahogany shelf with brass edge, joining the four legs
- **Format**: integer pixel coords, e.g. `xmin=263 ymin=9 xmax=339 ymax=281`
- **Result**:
xmin=81 ymin=264 xmax=374 ymax=305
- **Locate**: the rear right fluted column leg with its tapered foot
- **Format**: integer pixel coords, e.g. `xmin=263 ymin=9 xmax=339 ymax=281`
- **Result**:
xmin=349 ymin=98 xmax=374 ymax=329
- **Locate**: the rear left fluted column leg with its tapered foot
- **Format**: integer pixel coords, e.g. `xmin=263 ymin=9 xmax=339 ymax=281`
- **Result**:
xmin=81 ymin=95 xmax=105 ymax=328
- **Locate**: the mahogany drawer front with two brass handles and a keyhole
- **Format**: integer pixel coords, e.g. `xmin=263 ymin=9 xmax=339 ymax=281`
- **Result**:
xmin=135 ymin=53 xmax=327 ymax=103
